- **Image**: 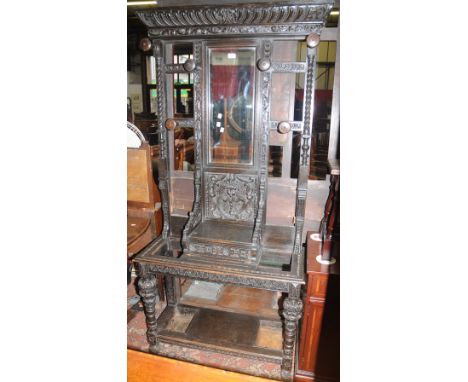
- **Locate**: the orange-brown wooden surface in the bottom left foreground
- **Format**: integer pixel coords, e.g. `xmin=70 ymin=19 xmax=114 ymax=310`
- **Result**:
xmin=127 ymin=349 xmax=277 ymax=382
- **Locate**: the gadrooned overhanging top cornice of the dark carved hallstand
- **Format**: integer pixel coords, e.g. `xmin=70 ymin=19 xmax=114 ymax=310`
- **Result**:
xmin=136 ymin=3 xmax=332 ymax=28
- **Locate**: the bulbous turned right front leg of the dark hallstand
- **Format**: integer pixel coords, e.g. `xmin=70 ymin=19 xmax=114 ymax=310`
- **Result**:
xmin=281 ymin=286 xmax=303 ymax=381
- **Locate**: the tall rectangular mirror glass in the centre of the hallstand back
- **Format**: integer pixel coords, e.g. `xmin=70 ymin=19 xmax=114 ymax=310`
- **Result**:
xmin=209 ymin=47 xmax=255 ymax=164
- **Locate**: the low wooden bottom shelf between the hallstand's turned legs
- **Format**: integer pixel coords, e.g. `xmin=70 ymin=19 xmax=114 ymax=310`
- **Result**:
xmin=152 ymin=304 xmax=282 ymax=363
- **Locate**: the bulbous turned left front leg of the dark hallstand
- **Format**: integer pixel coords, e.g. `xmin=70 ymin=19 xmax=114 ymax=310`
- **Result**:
xmin=138 ymin=273 xmax=158 ymax=351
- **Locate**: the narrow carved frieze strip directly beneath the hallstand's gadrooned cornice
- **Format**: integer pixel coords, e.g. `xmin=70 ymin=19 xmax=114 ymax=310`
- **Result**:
xmin=148 ymin=23 xmax=323 ymax=38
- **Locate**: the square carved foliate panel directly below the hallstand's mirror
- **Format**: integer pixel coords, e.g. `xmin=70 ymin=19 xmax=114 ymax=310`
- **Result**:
xmin=204 ymin=172 xmax=257 ymax=221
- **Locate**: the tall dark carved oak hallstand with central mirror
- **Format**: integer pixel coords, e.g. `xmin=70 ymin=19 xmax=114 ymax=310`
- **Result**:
xmin=135 ymin=0 xmax=333 ymax=380
